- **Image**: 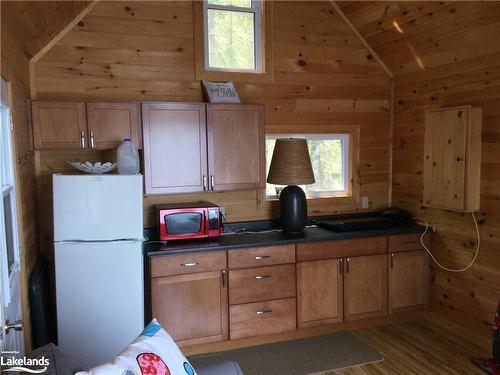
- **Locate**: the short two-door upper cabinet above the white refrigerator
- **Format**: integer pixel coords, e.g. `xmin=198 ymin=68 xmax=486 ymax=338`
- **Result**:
xmin=31 ymin=101 xmax=142 ymax=150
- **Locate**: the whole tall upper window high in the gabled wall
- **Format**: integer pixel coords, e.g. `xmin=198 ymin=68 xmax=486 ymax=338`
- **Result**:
xmin=203 ymin=0 xmax=263 ymax=73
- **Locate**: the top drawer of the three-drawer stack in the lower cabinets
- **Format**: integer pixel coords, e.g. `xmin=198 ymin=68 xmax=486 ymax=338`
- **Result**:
xmin=228 ymin=245 xmax=295 ymax=269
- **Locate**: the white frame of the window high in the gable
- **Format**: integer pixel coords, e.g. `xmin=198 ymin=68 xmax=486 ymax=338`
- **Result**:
xmin=203 ymin=0 xmax=264 ymax=74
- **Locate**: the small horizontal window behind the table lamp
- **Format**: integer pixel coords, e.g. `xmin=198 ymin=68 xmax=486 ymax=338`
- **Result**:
xmin=266 ymin=134 xmax=351 ymax=198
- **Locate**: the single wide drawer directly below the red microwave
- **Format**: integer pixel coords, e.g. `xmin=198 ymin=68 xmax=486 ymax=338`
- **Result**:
xmin=151 ymin=251 xmax=227 ymax=277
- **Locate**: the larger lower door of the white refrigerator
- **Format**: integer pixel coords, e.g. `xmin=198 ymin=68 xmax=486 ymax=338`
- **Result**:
xmin=55 ymin=241 xmax=144 ymax=368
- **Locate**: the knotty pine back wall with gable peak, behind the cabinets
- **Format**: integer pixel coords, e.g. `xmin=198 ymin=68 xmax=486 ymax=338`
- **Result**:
xmin=33 ymin=1 xmax=389 ymax=245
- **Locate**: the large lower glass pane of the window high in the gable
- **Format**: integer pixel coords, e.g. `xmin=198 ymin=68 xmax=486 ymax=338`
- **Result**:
xmin=208 ymin=9 xmax=255 ymax=69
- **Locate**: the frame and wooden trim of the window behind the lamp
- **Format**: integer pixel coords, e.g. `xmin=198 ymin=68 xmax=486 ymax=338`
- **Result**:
xmin=264 ymin=132 xmax=354 ymax=200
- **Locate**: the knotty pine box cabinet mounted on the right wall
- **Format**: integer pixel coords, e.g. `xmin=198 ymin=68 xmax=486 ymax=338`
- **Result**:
xmin=423 ymin=106 xmax=481 ymax=211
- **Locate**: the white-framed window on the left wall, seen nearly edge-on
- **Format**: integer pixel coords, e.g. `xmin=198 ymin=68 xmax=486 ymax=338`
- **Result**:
xmin=0 ymin=78 xmax=19 ymax=304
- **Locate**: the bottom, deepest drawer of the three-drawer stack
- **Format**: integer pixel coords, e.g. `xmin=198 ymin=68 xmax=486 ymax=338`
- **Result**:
xmin=229 ymin=298 xmax=296 ymax=340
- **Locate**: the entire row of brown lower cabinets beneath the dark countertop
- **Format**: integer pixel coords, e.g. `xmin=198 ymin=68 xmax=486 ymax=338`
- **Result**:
xmin=150 ymin=234 xmax=429 ymax=346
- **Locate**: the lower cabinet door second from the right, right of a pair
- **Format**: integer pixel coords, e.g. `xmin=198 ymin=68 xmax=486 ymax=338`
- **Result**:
xmin=344 ymin=254 xmax=387 ymax=321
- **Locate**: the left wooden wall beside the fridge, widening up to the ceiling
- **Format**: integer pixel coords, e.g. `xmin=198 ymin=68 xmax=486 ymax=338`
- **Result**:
xmin=0 ymin=1 xmax=100 ymax=351
